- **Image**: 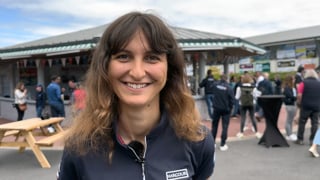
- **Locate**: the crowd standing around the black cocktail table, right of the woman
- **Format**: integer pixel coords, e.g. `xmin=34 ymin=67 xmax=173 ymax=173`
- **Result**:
xmin=199 ymin=66 xmax=320 ymax=157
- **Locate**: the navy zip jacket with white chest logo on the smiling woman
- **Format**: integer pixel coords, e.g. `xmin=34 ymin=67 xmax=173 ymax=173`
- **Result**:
xmin=59 ymin=110 xmax=214 ymax=180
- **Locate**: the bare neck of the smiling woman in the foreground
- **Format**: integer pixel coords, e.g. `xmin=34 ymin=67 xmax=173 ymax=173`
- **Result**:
xmin=118 ymin=105 xmax=160 ymax=144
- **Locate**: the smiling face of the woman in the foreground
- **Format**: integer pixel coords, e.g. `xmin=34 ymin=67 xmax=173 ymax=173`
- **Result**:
xmin=108 ymin=31 xmax=168 ymax=107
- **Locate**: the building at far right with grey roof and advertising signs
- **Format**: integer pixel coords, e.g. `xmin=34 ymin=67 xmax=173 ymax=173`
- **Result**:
xmin=244 ymin=26 xmax=320 ymax=72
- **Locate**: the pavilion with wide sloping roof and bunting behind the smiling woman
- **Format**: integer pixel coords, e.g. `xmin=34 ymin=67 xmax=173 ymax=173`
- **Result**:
xmin=0 ymin=25 xmax=265 ymax=119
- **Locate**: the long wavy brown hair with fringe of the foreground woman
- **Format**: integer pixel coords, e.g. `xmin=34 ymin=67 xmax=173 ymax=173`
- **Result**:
xmin=65 ymin=12 xmax=204 ymax=158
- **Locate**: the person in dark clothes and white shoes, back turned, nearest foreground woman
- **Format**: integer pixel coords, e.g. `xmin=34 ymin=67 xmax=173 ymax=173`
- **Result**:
xmin=212 ymin=75 xmax=234 ymax=151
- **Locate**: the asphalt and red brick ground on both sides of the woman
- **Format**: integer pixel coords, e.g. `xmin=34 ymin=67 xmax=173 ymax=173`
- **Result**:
xmin=0 ymin=106 xmax=320 ymax=180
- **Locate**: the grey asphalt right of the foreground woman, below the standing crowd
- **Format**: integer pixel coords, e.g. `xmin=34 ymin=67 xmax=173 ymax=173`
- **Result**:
xmin=210 ymin=134 xmax=320 ymax=180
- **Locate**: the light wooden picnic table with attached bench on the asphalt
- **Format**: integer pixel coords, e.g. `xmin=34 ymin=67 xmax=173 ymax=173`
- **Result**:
xmin=0 ymin=117 xmax=67 ymax=168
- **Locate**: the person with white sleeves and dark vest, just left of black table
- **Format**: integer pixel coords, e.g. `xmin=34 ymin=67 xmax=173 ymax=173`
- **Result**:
xmin=235 ymin=75 xmax=261 ymax=138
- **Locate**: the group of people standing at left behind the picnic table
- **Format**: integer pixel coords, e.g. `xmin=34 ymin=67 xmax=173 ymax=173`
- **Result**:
xmin=13 ymin=75 xmax=85 ymax=133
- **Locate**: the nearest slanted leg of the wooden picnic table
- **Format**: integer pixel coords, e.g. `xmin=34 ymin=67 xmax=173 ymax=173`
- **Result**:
xmin=24 ymin=131 xmax=51 ymax=168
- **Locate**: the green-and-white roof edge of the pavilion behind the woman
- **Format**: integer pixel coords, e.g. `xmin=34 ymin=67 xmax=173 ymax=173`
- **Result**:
xmin=0 ymin=38 xmax=266 ymax=60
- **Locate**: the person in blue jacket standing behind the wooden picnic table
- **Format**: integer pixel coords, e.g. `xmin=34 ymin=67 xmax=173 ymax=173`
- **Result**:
xmin=47 ymin=75 xmax=65 ymax=133
